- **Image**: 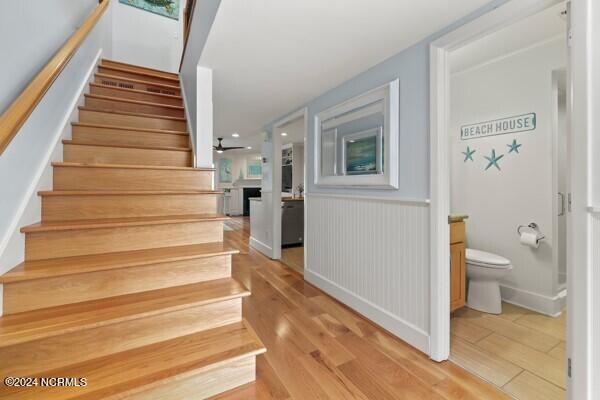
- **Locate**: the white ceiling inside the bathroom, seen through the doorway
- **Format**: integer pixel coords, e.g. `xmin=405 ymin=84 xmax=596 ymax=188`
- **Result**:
xmin=450 ymin=3 xmax=567 ymax=73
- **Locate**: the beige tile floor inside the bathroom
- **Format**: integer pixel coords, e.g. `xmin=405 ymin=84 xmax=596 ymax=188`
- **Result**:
xmin=450 ymin=303 xmax=567 ymax=400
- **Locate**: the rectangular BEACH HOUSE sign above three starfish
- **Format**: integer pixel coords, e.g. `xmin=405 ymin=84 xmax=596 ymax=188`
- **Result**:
xmin=460 ymin=113 xmax=537 ymax=140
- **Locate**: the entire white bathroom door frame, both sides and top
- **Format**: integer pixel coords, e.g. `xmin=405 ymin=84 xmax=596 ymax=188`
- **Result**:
xmin=430 ymin=0 xmax=600 ymax=400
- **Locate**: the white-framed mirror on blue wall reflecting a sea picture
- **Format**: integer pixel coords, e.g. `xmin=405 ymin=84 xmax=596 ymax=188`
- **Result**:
xmin=314 ymin=80 xmax=400 ymax=189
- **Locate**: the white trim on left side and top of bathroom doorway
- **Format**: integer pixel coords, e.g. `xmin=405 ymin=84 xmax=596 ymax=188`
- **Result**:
xmin=429 ymin=0 xmax=561 ymax=361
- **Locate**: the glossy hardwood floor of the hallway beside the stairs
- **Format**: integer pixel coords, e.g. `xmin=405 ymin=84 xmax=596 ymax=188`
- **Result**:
xmin=213 ymin=218 xmax=508 ymax=400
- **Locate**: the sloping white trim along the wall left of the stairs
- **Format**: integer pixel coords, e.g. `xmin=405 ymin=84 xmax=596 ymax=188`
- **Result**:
xmin=0 ymin=49 xmax=103 ymax=262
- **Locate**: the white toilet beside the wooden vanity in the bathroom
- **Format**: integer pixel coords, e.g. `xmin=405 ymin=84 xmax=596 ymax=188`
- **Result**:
xmin=465 ymin=249 xmax=513 ymax=314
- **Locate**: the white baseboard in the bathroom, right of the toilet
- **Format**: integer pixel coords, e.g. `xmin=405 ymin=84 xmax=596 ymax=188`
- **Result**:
xmin=500 ymin=285 xmax=567 ymax=317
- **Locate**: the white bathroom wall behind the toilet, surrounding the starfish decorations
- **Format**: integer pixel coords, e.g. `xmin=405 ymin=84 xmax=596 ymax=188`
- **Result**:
xmin=449 ymin=38 xmax=566 ymax=314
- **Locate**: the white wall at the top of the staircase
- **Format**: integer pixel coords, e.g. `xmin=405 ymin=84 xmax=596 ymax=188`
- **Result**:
xmin=112 ymin=0 xmax=186 ymax=72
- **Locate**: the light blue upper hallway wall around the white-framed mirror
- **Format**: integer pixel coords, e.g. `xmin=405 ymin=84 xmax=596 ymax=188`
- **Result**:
xmin=265 ymin=0 xmax=508 ymax=200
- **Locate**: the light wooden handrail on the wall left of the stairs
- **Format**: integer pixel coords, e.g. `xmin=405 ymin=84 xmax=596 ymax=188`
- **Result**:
xmin=0 ymin=0 xmax=110 ymax=155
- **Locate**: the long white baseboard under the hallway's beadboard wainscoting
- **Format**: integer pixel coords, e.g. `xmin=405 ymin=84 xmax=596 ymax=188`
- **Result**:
xmin=304 ymin=269 xmax=429 ymax=354
